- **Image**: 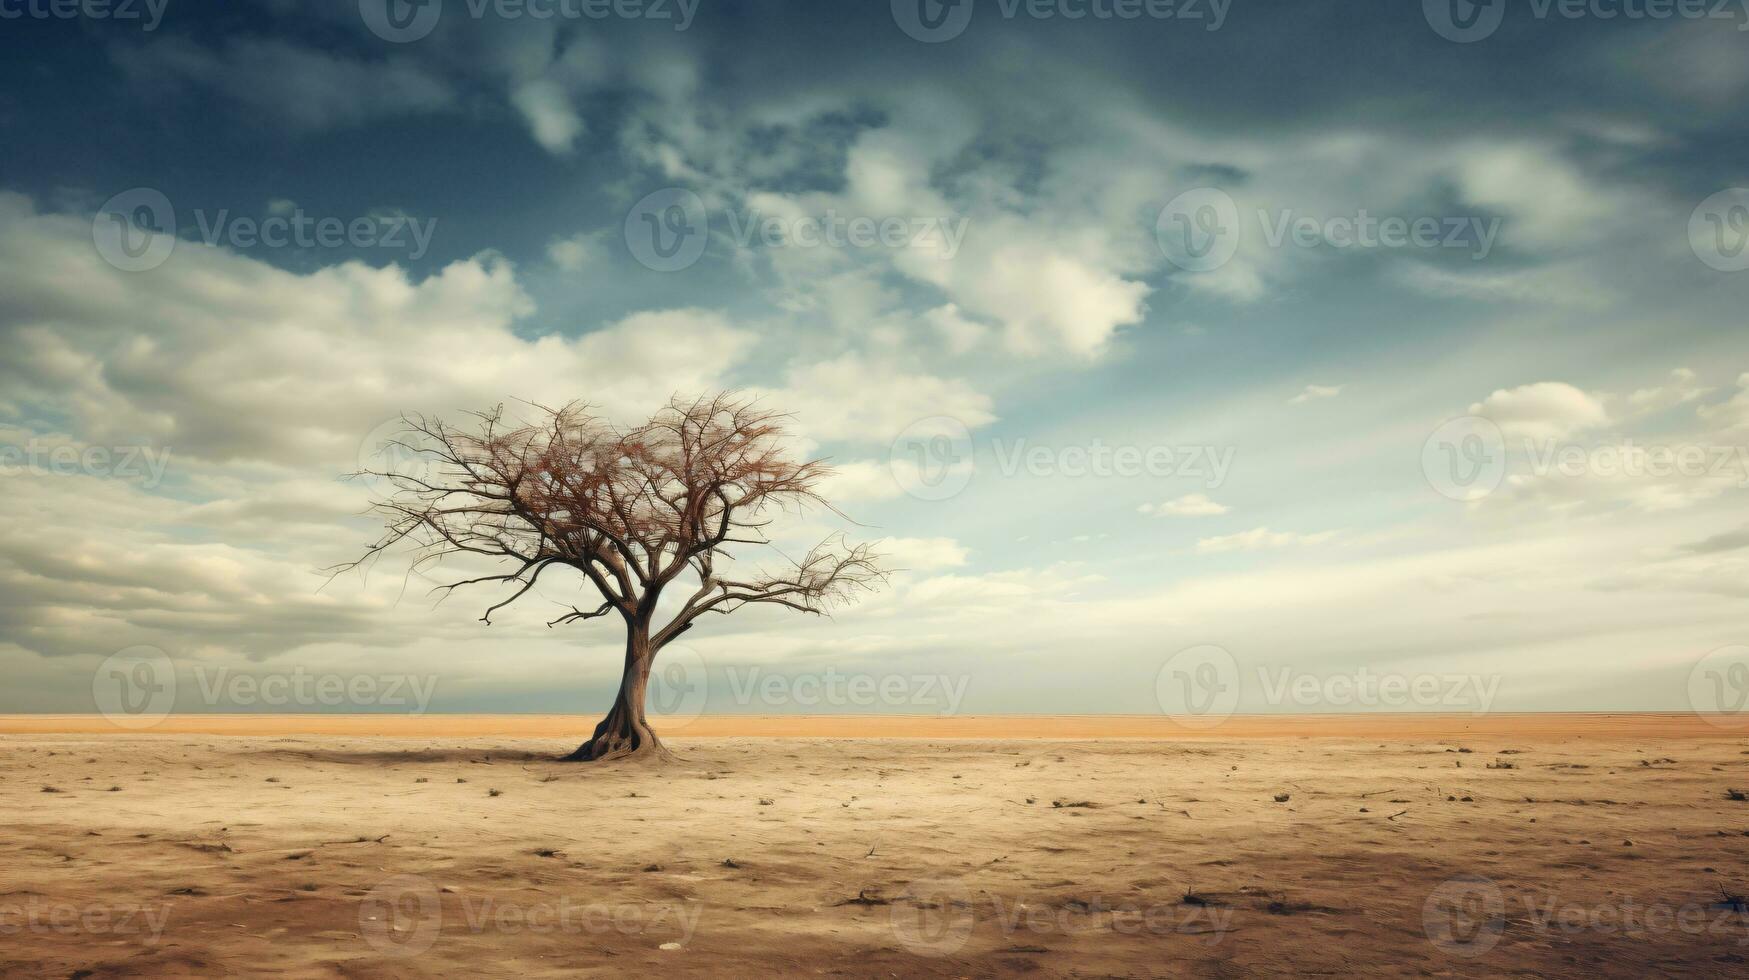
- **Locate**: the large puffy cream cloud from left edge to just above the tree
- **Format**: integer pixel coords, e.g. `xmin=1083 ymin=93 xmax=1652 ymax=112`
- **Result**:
xmin=0 ymin=196 xmax=752 ymax=471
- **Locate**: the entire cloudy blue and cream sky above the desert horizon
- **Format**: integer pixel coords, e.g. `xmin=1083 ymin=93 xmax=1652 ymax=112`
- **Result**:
xmin=0 ymin=0 xmax=1749 ymax=721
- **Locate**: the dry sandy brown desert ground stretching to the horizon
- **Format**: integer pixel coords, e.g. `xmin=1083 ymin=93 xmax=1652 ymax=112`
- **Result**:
xmin=0 ymin=716 xmax=1749 ymax=978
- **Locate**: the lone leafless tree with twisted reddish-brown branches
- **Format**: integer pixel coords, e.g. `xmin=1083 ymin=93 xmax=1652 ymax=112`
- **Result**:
xmin=336 ymin=394 xmax=883 ymax=761
